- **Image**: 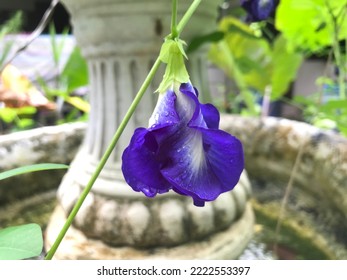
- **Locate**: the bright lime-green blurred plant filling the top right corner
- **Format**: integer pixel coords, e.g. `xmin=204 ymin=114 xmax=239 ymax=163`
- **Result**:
xmin=275 ymin=0 xmax=347 ymax=135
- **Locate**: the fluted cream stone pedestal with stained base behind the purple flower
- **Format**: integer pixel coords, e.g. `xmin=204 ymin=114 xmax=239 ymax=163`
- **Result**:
xmin=46 ymin=0 xmax=254 ymax=259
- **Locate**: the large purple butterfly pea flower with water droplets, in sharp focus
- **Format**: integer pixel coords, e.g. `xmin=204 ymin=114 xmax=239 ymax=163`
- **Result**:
xmin=122 ymin=82 xmax=244 ymax=206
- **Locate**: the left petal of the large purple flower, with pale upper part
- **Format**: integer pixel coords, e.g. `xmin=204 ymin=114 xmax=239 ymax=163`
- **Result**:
xmin=122 ymin=90 xmax=179 ymax=197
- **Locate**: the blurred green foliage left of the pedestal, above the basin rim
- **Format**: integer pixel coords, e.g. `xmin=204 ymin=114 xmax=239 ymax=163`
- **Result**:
xmin=0 ymin=17 xmax=89 ymax=133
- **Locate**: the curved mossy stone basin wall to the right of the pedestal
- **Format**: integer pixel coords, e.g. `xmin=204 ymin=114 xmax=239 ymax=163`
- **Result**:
xmin=221 ymin=115 xmax=347 ymax=248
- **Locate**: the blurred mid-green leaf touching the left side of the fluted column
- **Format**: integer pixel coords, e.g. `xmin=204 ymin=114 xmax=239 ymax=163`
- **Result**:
xmin=61 ymin=47 xmax=88 ymax=93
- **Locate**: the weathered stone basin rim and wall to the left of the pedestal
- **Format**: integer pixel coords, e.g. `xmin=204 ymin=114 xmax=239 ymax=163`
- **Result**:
xmin=0 ymin=123 xmax=86 ymax=205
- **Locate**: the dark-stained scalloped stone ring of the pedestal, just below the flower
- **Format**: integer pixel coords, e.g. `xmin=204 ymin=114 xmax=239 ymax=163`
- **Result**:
xmin=56 ymin=171 xmax=251 ymax=248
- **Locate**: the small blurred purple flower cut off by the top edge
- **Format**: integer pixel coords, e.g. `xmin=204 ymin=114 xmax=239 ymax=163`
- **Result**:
xmin=241 ymin=0 xmax=275 ymax=22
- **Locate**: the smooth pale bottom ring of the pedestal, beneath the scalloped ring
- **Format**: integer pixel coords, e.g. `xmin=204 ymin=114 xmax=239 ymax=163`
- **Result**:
xmin=45 ymin=202 xmax=254 ymax=260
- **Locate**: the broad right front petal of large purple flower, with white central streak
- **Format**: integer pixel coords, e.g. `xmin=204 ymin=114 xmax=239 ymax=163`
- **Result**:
xmin=162 ymin=123 xmax=244 ymax=207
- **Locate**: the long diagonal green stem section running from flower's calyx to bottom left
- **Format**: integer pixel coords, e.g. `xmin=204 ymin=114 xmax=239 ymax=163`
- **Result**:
xmin=45 ymin=58 xmax=161 ymax=260
